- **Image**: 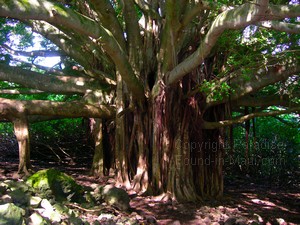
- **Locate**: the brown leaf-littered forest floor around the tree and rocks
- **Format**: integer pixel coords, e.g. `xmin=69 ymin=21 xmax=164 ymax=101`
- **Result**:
xmin=0 ymin=138 xmax=300 ymax=225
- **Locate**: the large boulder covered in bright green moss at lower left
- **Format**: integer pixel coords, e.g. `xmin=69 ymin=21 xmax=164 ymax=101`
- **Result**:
xmin=26 ymin=169 xmax=84 ymax=202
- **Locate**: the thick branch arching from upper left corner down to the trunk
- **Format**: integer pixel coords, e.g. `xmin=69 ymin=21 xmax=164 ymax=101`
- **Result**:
xmin=0 ymin=0 xmax=144 ymax=99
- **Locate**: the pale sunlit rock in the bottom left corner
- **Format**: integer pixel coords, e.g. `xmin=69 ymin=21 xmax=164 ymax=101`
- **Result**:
xmin=0 ymin=203 xmax=25 ymax=225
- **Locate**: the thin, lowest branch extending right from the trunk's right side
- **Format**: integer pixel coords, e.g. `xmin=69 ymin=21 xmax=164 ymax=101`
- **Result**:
xmin=203 ymin=106 xmax=300 ymax=129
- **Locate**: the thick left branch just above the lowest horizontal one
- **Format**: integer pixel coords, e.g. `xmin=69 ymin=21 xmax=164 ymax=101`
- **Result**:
xmin=0 ymin=64 xmax=107 ymax=94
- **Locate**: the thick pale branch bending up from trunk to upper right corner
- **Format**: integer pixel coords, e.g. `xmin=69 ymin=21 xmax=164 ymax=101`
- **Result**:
xmin=166 ymin=0 xmax=300 ymax=85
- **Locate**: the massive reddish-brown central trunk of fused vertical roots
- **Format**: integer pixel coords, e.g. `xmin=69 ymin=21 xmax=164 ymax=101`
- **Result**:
xmin=112 ymin=75 xmax=224 ymax=201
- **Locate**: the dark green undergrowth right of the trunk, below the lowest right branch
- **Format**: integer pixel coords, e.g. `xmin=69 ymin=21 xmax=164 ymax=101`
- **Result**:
xmin=226 ymin=115 xmax=300 ymax=185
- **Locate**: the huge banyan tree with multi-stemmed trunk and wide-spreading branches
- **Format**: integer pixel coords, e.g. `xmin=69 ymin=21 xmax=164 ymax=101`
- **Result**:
xmin=0 ymin=0 xmax=300 ymax=201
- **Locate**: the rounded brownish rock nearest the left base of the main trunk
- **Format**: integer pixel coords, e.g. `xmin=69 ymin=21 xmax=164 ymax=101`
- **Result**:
xmin=102 ymin=185 xmax=130 ymax=211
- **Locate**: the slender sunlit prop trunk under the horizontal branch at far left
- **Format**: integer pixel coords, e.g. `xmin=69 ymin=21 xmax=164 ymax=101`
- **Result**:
xmin=13 ymin=117 xmax=31 ymax=175
